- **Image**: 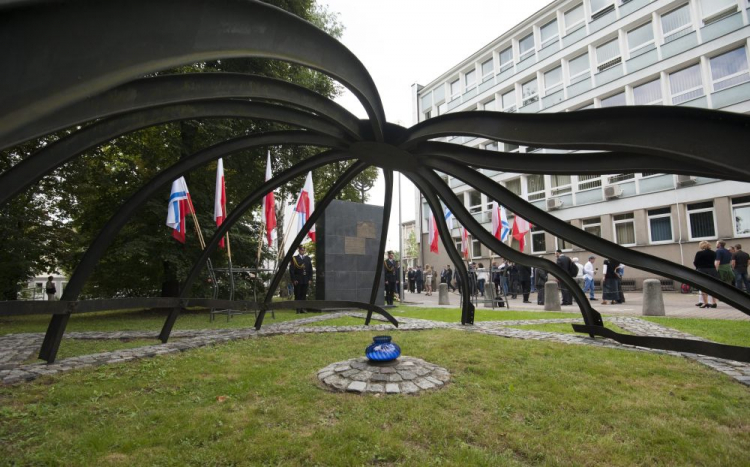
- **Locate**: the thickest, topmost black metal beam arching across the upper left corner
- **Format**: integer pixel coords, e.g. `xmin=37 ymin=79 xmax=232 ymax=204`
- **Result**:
xmin=0 ymin=0 xmax=385 ymax=140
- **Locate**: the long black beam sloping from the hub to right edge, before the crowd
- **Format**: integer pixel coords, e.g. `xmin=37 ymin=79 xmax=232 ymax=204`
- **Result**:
xmin=424 ymin=159 xmax=750 ymax=315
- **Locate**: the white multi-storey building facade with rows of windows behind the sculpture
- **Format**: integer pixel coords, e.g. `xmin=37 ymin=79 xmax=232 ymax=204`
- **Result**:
xmin=412 ymin=0 xmax=750 ymax=287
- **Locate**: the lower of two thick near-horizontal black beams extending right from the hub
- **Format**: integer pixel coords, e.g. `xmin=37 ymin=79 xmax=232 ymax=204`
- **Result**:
xmin=414 ymin=141 xmax=742 ymax=181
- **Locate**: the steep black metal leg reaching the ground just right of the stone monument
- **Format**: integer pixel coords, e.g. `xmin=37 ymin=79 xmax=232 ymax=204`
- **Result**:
xmin=403 ymin=168 xmax=474 ymax=325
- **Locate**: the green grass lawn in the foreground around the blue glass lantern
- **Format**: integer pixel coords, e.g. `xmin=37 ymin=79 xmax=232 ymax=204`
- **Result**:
xmin=0 ymin=330 xmax=750 ymax=466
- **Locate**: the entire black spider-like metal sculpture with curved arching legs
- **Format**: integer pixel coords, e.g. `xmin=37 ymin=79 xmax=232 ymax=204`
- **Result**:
xmin=0 ymin=0 xmax=750 ymax=362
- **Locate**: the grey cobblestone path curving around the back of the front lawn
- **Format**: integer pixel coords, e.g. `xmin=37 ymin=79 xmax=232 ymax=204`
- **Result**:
xmin=0 ymin=312 xmax=750 ymax=386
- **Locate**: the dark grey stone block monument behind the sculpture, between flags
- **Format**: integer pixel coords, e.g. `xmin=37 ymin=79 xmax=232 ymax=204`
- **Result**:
xmin=315 ymin=201 xmax=385 ymax=305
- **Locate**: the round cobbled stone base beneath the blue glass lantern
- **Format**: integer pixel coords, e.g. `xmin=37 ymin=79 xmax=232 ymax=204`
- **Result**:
xmin=318 ymin=355 xmax=451 ymax=394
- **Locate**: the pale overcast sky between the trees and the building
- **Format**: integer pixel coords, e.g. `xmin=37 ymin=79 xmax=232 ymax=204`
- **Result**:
xmin=318 ymin=0 xmax=551 ymax=249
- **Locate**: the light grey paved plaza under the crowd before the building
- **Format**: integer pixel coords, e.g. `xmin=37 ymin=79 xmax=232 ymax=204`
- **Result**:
xmin=396 ymin=292 xmax=750 ymax=321
